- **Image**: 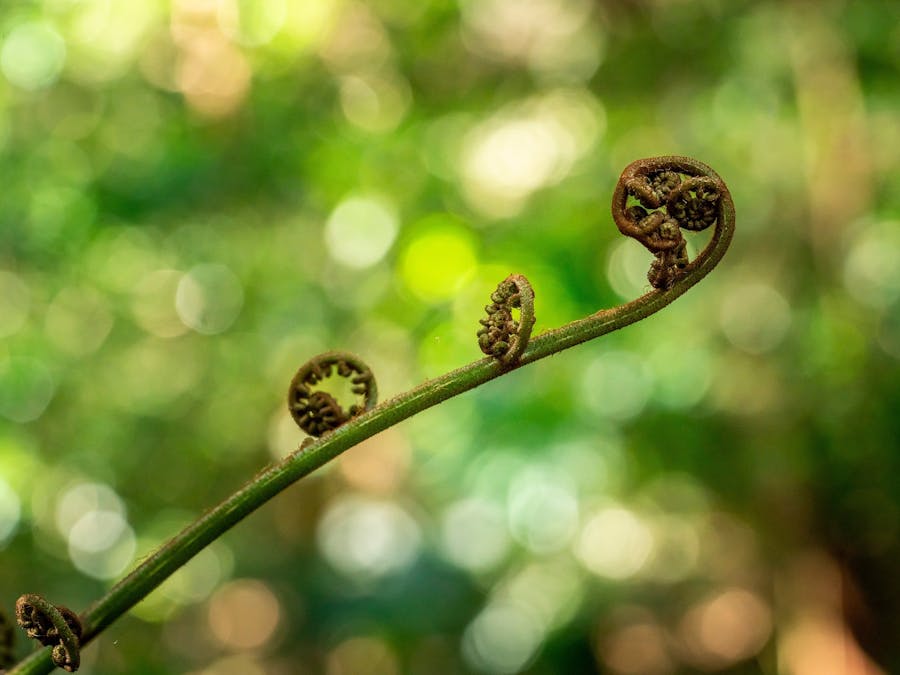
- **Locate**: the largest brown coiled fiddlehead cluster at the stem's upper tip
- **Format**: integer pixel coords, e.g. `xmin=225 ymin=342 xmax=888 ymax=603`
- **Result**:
xmin=612 ymin=156 xmax=733 ymax=290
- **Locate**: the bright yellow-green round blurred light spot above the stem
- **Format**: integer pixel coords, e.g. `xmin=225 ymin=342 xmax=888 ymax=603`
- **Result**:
xmin=399 ymin=213 xmax=478 ymax=303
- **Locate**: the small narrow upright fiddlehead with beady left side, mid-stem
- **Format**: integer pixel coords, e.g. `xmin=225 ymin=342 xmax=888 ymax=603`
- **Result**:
xmin=477 ymin=274 xmax=534 ymax=365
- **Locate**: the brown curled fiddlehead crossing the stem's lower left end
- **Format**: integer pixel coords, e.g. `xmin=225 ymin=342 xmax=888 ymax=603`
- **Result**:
xmin=16 ymin=593 xmax=82 ymax=673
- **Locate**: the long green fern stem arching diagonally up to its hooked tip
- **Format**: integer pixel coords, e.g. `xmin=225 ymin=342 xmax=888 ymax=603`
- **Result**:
xmin=8 ymin=158 xmax=735 ymax=675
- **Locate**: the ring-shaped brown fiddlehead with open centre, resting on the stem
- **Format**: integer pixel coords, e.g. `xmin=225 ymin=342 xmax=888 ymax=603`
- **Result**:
xmin=288 ymin=352 xmax=378 ymax=436
